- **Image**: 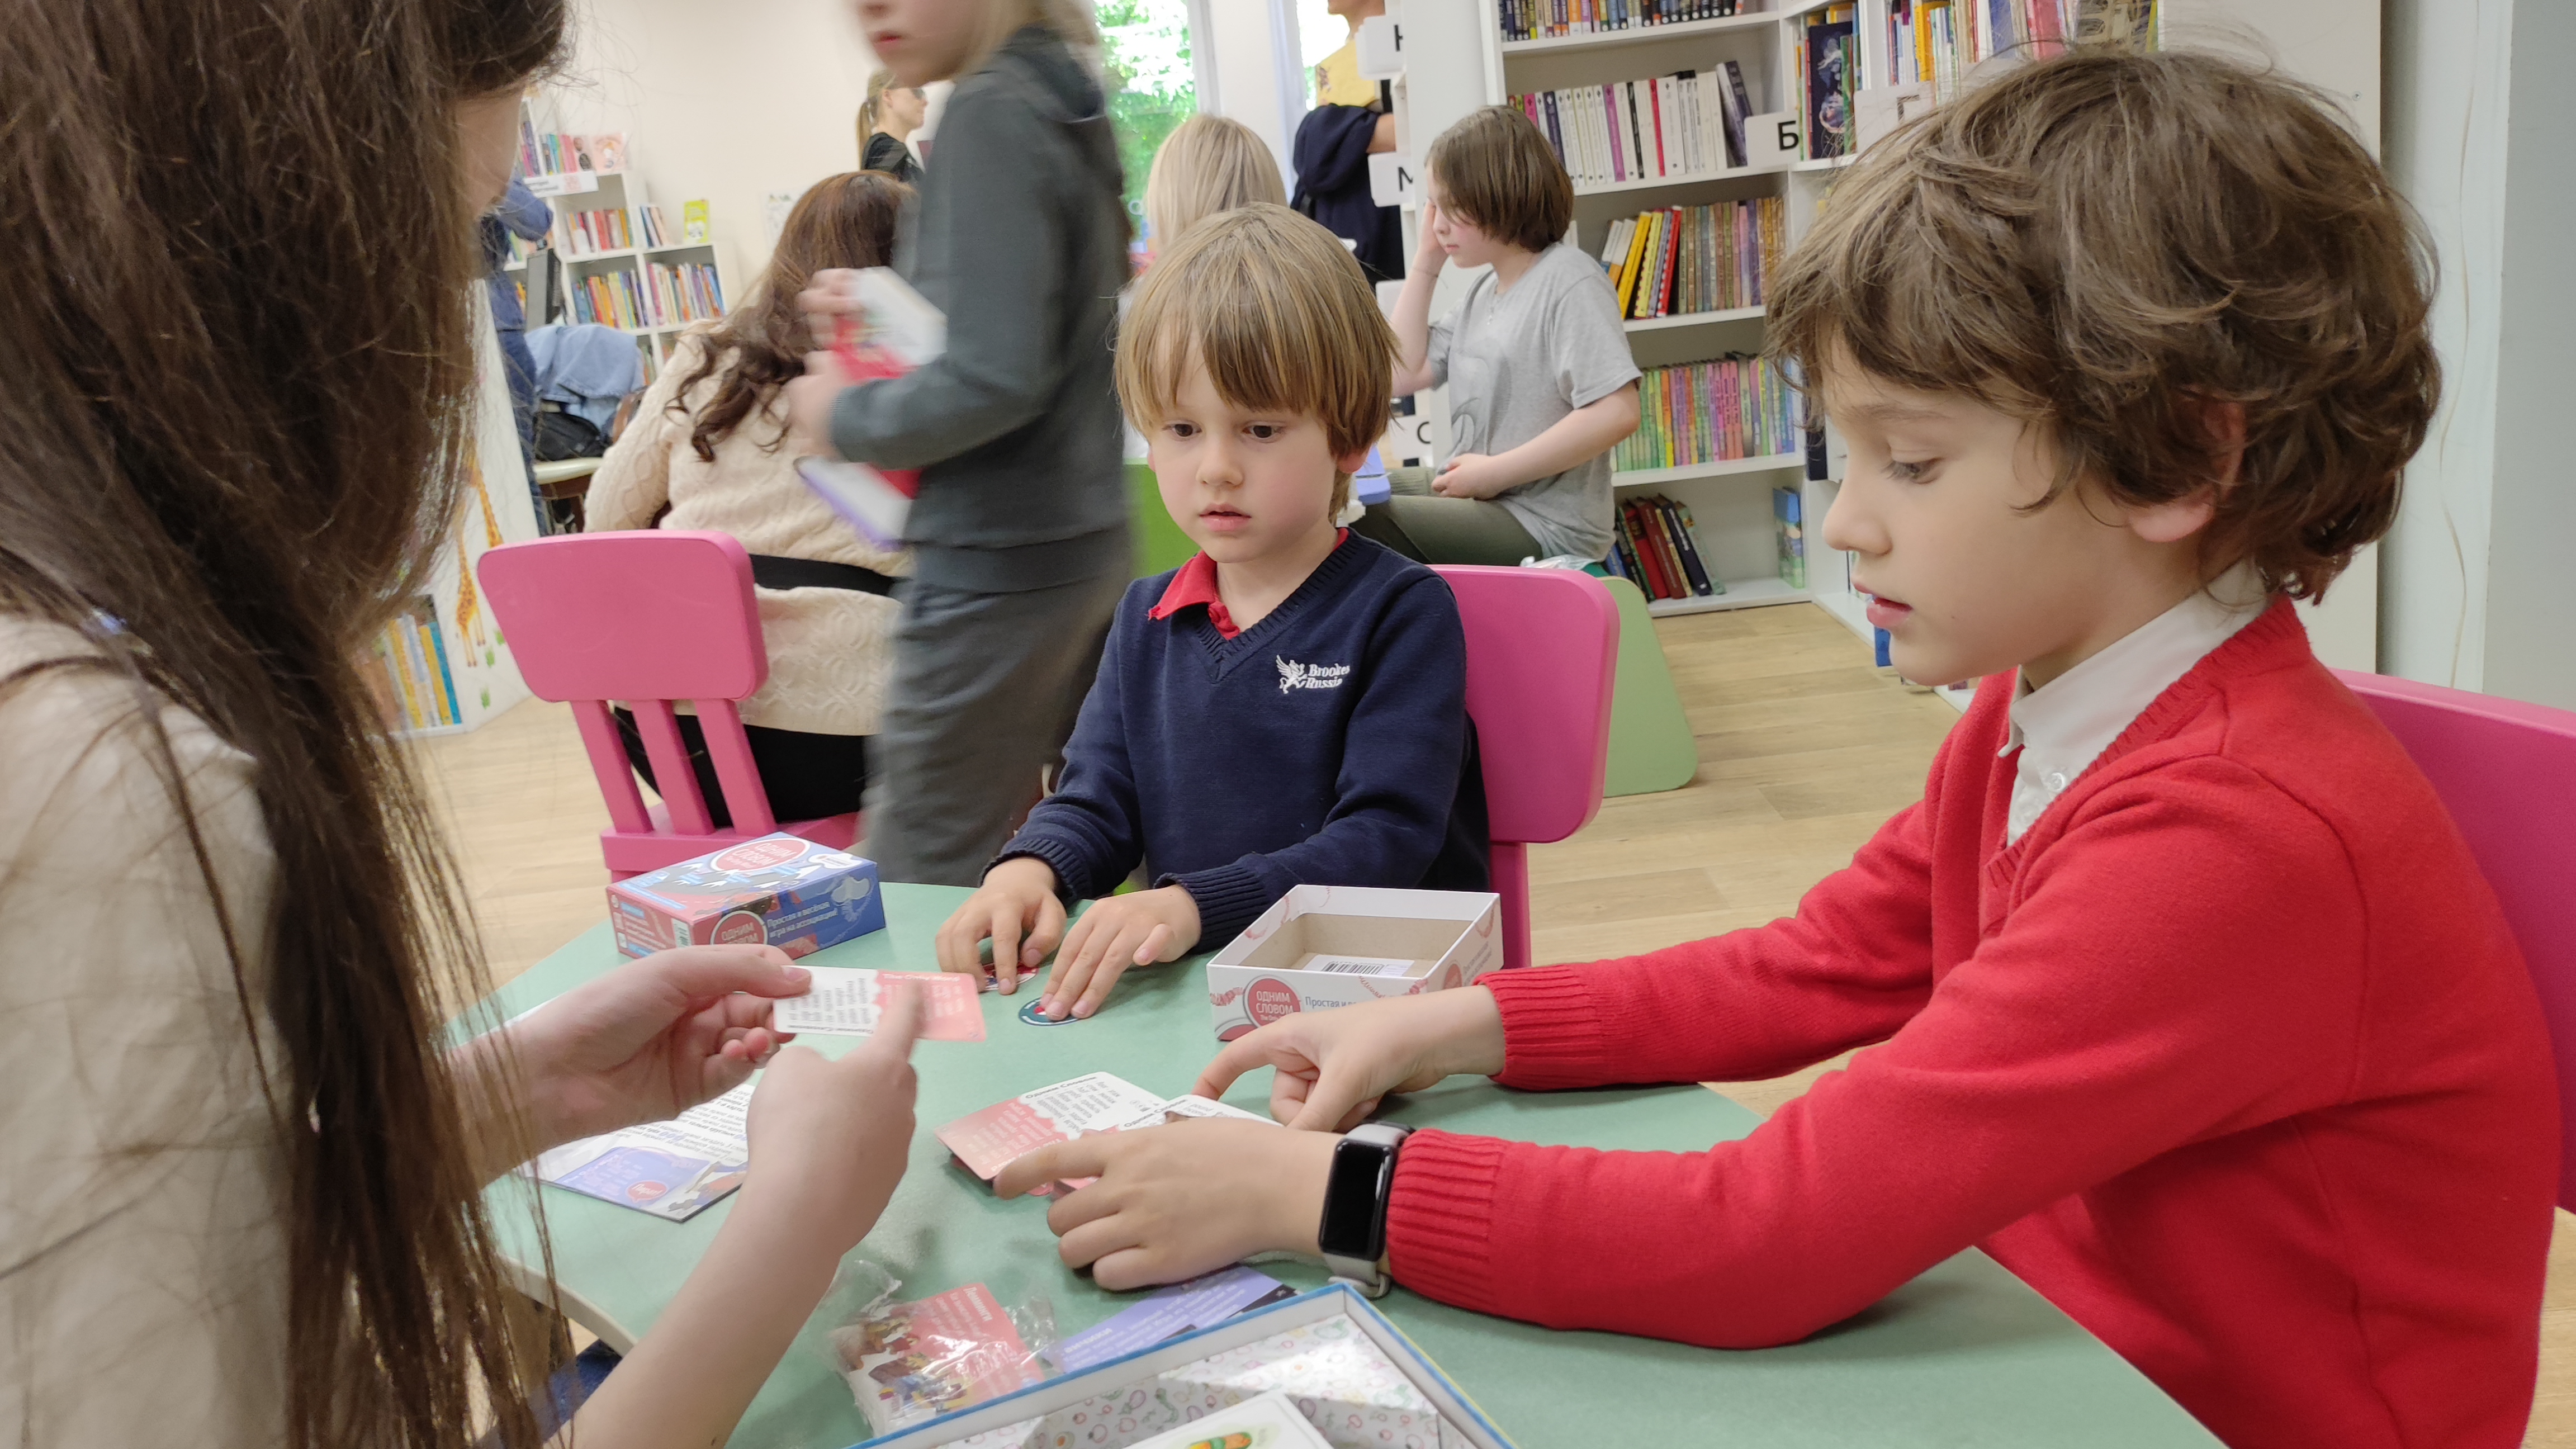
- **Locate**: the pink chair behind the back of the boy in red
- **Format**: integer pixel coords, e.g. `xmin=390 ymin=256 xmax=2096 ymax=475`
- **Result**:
xmin=2334 ymin=670 xmax=2576 ymax=1209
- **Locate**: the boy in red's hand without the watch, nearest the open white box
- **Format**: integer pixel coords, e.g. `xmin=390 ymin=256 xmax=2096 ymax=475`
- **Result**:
xmin=1190 ymin=985 xmax=1502 ymax=1132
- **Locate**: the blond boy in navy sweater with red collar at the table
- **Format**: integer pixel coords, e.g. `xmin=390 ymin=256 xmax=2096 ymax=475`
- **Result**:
xmin=937 ymin=203 xmax=1486 ymax=1019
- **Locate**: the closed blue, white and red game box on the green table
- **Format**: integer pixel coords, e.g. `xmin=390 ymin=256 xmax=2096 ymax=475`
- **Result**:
xmin=608 ymin=830 xmax=886 ymax=956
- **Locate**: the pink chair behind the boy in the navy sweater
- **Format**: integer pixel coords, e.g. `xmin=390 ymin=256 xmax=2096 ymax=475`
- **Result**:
xmin=1437 ymin=565 xmax=1618 ymax=967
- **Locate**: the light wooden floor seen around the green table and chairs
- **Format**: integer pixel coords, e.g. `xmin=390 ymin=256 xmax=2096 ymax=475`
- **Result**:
xmin=417 ymin=603 xmax=2576 ymax=1449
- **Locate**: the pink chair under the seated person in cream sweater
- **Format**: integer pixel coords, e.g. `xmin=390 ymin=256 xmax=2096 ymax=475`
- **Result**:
xmin=479 ymin=531 xmax=858 ymax=879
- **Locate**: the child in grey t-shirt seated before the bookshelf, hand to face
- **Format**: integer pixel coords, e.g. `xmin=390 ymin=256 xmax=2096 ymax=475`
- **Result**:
xmin=1355 ymin=106 xmax=1639 ymax=565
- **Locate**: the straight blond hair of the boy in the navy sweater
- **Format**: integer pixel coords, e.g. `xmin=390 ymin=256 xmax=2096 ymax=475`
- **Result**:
xmin=1118 ymin=201 xmax=1396 ymax=513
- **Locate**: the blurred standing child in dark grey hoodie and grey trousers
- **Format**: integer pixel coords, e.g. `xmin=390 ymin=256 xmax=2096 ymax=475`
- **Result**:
xmin=788 ymin=0 xmax=1128 ymax=884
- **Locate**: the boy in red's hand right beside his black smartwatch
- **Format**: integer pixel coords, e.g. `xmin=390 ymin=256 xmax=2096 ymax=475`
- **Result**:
xmin=992 ymin=1103 xmax=1339 ymax=1292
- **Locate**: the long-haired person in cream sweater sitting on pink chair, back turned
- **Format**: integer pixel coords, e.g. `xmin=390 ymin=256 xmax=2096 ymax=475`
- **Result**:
xmin=588 ymin=170 xmax=912 ymax=825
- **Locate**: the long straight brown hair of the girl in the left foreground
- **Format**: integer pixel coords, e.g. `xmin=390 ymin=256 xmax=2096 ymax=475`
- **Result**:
xmin=0 ymin=0 xmax=564 ymax=1449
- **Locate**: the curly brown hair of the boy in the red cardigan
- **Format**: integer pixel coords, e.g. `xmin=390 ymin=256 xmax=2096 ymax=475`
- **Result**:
xmin=1770 ymin=51 xmax=2442 ymax=598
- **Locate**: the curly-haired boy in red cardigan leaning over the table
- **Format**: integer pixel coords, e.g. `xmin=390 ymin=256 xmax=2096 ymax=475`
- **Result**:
xmin=1002 ymin=54 xmax=2558 ymax=1449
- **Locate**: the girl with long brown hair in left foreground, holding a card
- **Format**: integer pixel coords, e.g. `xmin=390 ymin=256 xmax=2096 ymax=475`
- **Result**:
xmin=0 ymin=0 xmax=912 ymax=1449
